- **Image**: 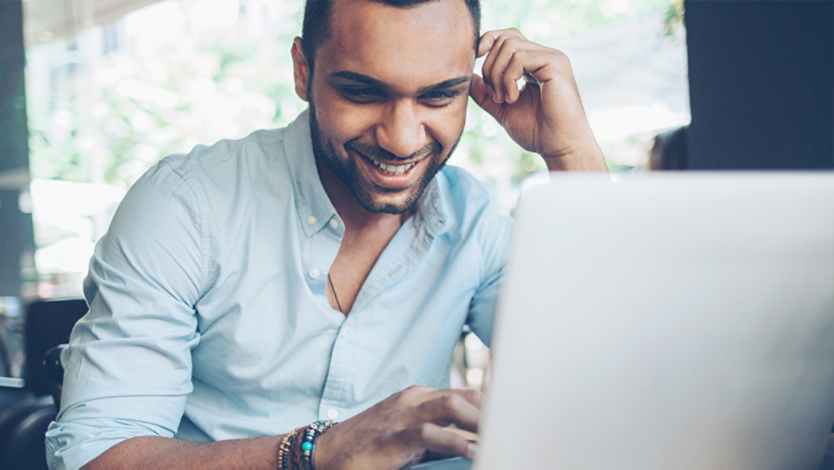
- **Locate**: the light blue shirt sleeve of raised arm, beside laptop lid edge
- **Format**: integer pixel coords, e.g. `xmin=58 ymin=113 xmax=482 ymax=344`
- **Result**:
xmin=466 ymin=208 xmax=515 ymax=346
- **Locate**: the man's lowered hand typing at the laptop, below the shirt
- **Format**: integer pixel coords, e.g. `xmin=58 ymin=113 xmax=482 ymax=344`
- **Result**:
xmin=315 ymin=386 xmax=483 ymax=470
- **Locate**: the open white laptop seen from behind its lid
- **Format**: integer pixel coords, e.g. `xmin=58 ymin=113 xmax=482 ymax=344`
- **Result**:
xmin=408 ymin=173 xmax=834 ymax=470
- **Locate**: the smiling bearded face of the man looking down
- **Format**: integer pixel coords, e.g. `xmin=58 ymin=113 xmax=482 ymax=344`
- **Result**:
xmin=307 ymin=0 xmax=475 ymax=214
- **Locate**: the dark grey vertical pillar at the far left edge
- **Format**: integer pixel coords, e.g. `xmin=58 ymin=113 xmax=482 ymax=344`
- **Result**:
xmin=0 ymin=0 xmax=34 ymax=296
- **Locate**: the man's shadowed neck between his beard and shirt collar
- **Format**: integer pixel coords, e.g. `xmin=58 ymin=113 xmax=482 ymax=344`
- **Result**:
xmin=315 ymin=152 xmax=411 ymax=232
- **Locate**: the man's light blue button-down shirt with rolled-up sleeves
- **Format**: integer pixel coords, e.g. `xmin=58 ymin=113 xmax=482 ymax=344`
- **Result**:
xmin=46 ymin=112 xmax=513 ymax=469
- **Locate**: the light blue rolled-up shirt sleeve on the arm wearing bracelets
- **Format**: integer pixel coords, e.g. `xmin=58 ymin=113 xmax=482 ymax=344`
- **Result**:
xmin=46 ymin=160 xmax=208 ymax=470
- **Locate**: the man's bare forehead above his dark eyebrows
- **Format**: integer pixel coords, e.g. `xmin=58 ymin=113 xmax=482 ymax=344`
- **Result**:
xmin=316 ymin=0 xmax=475 ymax=89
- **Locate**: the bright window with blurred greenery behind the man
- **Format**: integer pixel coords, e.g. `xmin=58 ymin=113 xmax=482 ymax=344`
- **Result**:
xmin=25 ymin=0 xmax=689 ymax=297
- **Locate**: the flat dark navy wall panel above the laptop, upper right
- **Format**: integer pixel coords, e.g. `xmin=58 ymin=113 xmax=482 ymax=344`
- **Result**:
xmin=685 ymin=0 xmax=834 ymax=169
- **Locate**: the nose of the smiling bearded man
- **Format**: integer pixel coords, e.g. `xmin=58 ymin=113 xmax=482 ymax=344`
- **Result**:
xmin=376 ymin=100 xmax=426 ymax=159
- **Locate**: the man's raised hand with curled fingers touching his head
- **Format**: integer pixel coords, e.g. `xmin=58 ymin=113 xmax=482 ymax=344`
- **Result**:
xmin=470 ymin=29 xmax=608 ymax=171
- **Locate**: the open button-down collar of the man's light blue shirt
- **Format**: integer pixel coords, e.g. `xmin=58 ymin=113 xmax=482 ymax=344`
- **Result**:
xmin=284 ymin=110 xmax=450 ymax=237
